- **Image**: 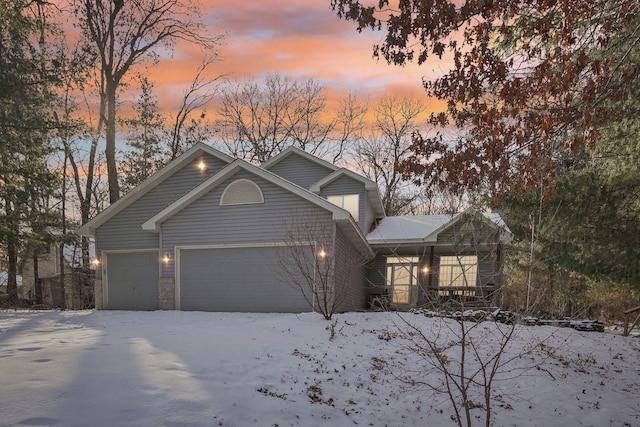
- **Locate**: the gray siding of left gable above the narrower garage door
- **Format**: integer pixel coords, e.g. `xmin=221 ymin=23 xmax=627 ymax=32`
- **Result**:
xmin=96 ymin=154 xmax=226 ymax=251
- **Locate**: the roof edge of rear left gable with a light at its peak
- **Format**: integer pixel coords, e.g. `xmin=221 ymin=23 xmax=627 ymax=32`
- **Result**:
xmin=76 ymin=143 xmax=233 ymax=237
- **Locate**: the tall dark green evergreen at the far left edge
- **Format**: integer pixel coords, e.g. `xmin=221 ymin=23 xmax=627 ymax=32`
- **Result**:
xmin=0 ymin=0 xmax=57 ymax=301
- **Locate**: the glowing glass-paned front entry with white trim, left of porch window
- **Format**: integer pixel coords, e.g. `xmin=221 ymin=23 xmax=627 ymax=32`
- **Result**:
xmin=386 ymin=257 xmax=420 ymax=304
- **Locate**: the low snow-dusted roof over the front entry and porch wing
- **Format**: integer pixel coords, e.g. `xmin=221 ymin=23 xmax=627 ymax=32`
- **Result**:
xmin=367 ymin=211 xmax=511 ymax=245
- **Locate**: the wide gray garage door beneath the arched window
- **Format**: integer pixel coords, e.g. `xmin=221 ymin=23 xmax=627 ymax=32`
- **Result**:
xmin=179 ymin=246 xmax=312 ymax=313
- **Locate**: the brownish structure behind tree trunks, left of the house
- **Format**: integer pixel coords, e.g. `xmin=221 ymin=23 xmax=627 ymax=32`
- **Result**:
xmin=19 ymin=244 xmax=95 ymax=310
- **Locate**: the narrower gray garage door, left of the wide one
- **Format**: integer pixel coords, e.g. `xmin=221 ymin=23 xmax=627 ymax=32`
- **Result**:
xmin=106 ymin=250 xmax=159 ymax=310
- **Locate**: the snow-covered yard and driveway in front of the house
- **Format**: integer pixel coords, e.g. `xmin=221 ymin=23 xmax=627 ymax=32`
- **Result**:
xmin=0 ymin=311 xmax=640 ymax=427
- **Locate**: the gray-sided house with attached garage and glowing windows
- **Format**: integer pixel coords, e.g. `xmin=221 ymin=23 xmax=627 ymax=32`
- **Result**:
xmin=78 ymin=144 xmax=510 ymax=312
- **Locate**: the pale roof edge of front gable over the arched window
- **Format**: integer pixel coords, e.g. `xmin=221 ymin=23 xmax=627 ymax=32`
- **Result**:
xmin=142 ymin=159 xmax=373 ymax=256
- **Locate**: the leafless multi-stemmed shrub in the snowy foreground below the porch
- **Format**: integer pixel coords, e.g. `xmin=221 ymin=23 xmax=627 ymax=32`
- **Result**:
xmin=385 ymin=316 xmax=524 ymax=427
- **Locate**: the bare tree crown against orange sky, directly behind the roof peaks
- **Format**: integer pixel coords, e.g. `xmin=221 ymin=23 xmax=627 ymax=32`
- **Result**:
xmin=218 ymin=74 xmax=365 ymax=163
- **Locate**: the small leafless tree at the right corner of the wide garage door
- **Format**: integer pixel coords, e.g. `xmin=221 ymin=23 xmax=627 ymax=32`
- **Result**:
xmin=277 ymin=215 xmax=368 ymax=320
